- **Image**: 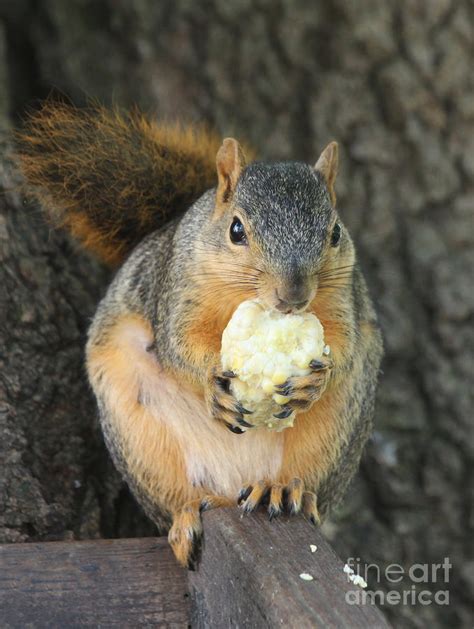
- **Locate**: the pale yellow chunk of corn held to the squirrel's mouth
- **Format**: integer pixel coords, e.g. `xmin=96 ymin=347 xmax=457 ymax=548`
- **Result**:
xmin=221 ymin=299 xmax=325 ymax=431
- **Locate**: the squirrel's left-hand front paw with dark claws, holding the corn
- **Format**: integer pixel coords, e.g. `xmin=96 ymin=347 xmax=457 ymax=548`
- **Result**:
xmin=207 ymin=368 xmax=253 ymax=435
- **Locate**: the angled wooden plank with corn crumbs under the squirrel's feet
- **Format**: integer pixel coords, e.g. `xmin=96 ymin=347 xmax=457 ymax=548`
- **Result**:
xmin=190 ymin=509 xmax=390 ymax=629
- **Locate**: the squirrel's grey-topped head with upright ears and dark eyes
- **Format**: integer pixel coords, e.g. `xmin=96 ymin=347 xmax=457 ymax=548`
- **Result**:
xmin=194 ymin=138 xmax=354 ymax=312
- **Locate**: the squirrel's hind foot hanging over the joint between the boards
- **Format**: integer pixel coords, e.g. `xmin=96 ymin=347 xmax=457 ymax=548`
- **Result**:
xmin=168 ymin=495 xmax=235 ymax=568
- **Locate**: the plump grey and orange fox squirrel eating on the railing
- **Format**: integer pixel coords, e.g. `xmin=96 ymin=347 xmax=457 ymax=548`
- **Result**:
xmin=17 ymin=103 xmax=382 ymax=565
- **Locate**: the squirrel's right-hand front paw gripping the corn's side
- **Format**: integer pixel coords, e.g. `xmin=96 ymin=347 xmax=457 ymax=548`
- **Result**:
xmin=275 ymin=360 xmax=332 ymax=419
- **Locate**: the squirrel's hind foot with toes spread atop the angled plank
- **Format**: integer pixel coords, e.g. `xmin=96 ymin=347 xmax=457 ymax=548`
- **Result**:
xmin=237 ymin=478 xmax=320 ymax=525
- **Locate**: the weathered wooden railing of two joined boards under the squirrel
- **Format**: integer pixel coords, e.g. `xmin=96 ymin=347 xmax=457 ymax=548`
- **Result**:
xmin=0 ymin=509 xmax=389 ymax=629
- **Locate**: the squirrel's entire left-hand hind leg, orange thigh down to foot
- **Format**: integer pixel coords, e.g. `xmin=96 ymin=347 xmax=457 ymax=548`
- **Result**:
xmin=87 ymin=314 xmax=241 ymax=565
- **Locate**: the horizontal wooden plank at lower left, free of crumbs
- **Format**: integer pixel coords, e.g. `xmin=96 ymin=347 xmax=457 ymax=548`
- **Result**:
xmin=0 ymin=538 xmax=189 ymax=629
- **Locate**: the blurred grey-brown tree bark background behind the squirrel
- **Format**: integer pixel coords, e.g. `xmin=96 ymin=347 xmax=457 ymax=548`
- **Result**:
xmin=0 ymin=0 xmax=474 ymax=627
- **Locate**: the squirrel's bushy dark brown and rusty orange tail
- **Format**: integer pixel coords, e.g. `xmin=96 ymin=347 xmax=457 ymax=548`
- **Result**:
xmin=16 ymin=102 xmax=219 ymax=265
